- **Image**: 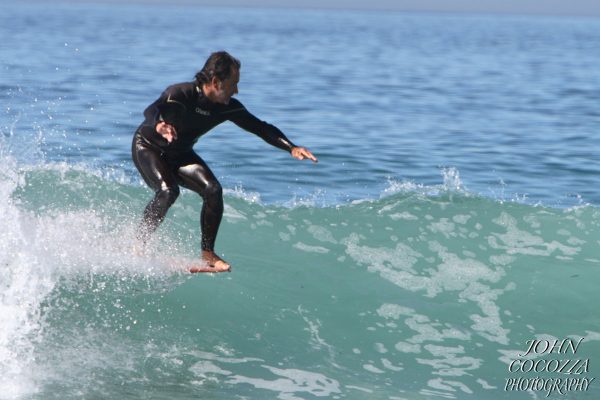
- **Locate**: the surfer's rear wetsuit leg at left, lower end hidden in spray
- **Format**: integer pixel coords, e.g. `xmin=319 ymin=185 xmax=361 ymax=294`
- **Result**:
xmin=132 ymin=135 xmax=179 ymax=242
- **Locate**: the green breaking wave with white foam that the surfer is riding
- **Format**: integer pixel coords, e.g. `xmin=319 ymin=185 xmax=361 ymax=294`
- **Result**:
xmin=0 ymin=154 xmax=600 ymax=399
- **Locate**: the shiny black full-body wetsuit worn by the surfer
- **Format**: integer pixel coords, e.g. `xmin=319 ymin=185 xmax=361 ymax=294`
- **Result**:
xmin=132 ymin=82 xmax=294 ymax=251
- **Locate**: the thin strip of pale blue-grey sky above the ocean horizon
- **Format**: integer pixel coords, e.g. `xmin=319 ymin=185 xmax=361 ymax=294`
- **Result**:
xmin=43 ymin=0 xmax=600 ymax=17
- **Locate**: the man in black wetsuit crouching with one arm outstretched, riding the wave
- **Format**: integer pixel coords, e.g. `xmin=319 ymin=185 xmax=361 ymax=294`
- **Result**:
xmin=132 ymin=51 xmax=317 ymax=272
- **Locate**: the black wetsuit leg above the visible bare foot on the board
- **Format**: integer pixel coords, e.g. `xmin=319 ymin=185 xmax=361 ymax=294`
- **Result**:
xmin=177 ymin=151 xmax=223 ymax=251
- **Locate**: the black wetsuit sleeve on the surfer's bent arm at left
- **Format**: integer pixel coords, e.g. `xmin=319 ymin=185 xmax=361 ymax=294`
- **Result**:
xmin=144 ymin=86 xmax=188 ymax=129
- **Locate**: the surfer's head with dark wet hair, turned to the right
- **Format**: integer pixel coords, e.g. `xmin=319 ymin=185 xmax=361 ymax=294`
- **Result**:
xmin=196 ymin=51 xmax=242 ymax=104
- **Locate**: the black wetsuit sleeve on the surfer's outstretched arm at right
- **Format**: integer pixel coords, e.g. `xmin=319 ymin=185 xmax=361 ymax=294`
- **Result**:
xmin=224 ymin=99 xmax=296 ymax=152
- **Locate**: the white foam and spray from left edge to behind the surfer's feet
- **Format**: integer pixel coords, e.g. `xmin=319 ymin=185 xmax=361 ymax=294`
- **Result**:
xmin=0 ymin=153 xmax=188 ymax=398
